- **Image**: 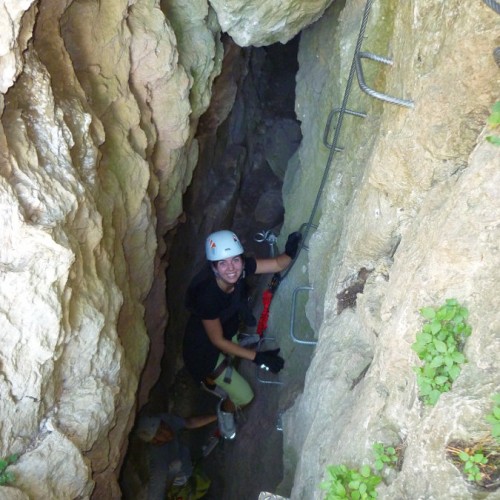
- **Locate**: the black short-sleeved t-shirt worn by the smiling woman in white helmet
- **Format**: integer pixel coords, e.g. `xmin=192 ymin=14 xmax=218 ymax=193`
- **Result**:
xmin=183 ymin=257 xmax=257 ymax=381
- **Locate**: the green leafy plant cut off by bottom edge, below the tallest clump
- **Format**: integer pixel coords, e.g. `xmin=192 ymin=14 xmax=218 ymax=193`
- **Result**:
xmin=321 ymin=465 xmax=382 ymax=500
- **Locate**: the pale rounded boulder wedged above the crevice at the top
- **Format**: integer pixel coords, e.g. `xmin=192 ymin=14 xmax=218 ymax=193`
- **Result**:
xmin=210 ymin=0 xmax=332 ymax=47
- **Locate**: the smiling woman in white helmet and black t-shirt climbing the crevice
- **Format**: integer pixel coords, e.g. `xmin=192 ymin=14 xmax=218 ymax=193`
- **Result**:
xmin=183 ymin=231 xmax=301 ymax=439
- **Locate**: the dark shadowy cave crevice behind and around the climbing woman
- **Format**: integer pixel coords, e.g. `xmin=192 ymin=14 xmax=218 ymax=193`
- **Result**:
xmin=120 ymin=36 xmax=301 ymax=500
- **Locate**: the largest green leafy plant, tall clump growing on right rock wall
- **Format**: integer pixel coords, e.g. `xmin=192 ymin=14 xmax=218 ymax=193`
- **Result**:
xmin=412 ymin=299 xmax=472 ymax=405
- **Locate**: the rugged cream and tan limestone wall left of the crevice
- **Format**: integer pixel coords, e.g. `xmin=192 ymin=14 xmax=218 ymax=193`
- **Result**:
xmin=0 ymin=0 xmax=221 ymax=499
